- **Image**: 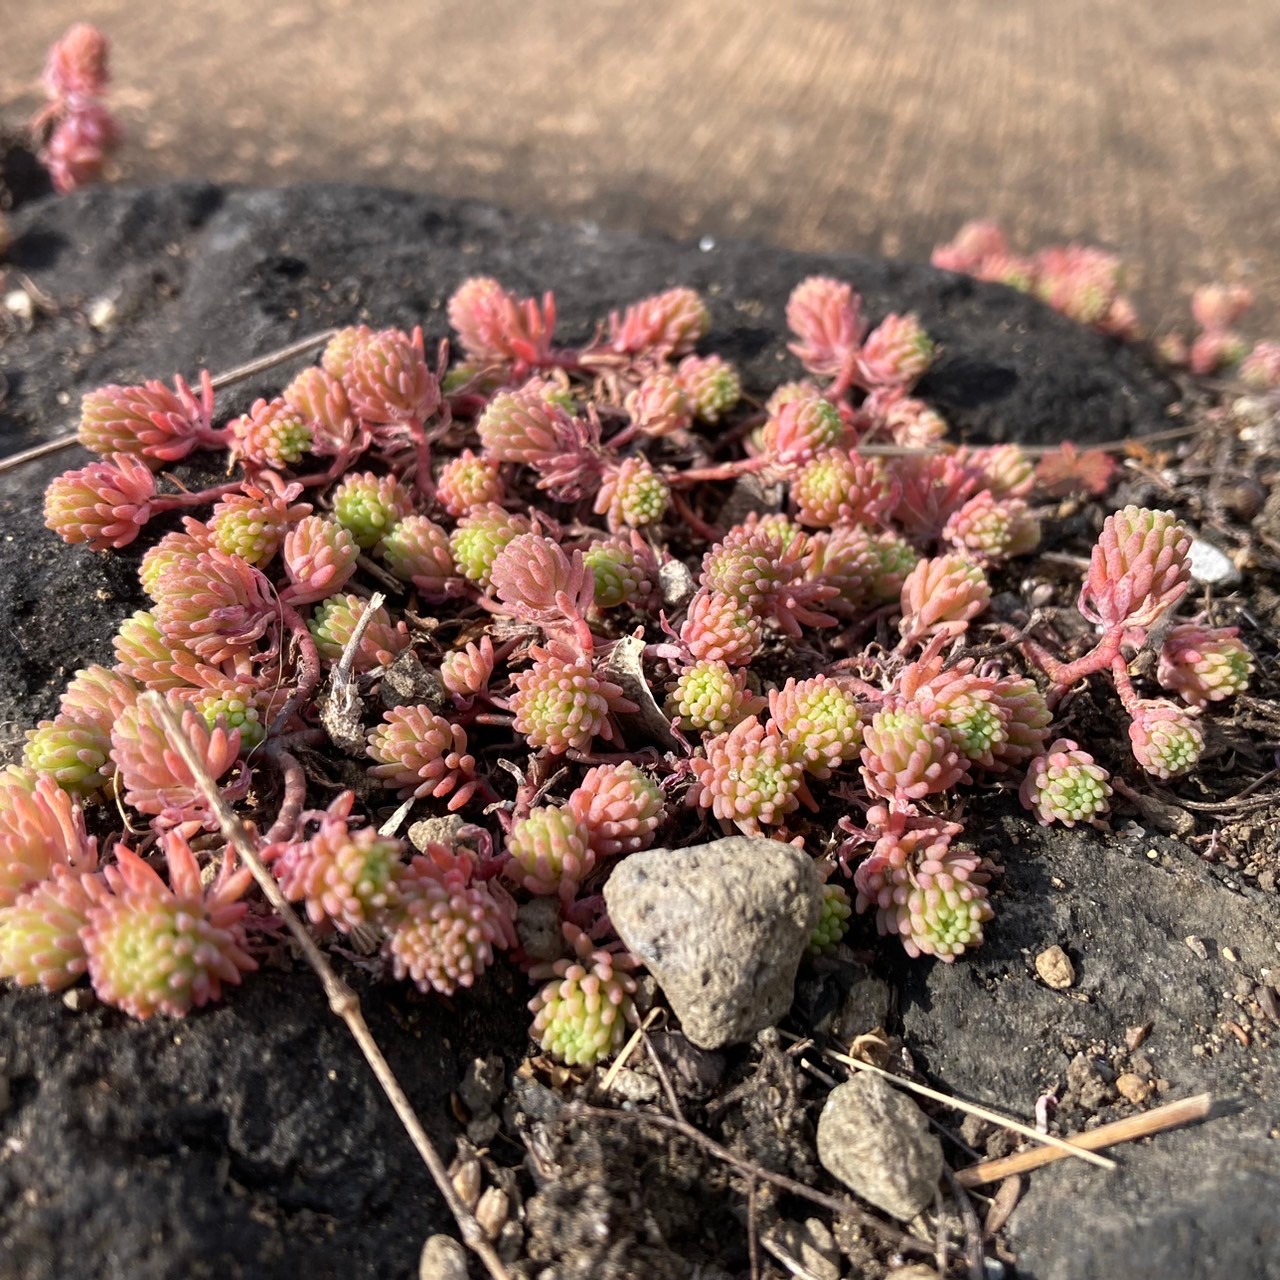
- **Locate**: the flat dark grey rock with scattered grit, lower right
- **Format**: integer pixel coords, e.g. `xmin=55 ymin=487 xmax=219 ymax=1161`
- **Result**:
xmin=899 ymin=818 xmax=1280 ymax=1280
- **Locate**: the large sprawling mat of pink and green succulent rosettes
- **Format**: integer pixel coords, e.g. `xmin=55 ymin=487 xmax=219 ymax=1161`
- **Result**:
xmin=0 ymin=261 xmax=1252 ymax=1064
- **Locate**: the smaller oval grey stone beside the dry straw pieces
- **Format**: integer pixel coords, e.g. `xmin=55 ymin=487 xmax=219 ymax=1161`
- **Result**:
xmin=818 ymin=1073 xmax=942 ymax=1221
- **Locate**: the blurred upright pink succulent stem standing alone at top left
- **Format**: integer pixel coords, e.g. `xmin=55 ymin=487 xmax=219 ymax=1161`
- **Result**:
xmin=31 ymin=22 xmax=120 ymax=193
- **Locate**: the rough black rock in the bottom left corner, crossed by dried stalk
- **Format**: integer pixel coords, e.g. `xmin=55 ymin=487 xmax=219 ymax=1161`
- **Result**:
xmin=0 ymin=969 xmax=527 ymax=1280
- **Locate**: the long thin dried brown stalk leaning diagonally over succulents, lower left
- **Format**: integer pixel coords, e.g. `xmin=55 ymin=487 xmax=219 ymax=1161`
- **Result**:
xmin=142 ymin=692 xmax=509 ymax=1280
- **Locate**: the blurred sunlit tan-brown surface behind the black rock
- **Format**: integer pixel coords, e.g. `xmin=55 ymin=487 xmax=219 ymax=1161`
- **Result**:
xmin=0 ymin=0 xmax=1280 ymax=333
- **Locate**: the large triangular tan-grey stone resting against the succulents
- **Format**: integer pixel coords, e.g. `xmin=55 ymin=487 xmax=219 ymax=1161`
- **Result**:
xmin=604 ymin=836 xmax=820 ymax=1048
